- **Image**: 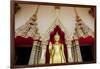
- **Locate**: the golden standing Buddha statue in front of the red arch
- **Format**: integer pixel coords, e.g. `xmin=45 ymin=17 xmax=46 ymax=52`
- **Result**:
xmin=49 ymin=33 xmax=66 ymax=64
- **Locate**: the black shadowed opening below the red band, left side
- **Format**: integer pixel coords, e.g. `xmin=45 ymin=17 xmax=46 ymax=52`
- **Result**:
xmin=15 ymin=47 xmax=32 ymax=65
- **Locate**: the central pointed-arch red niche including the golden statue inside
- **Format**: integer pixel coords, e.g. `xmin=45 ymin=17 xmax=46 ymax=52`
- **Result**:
xmin=46 ymin=25 xmax=67 ymax=64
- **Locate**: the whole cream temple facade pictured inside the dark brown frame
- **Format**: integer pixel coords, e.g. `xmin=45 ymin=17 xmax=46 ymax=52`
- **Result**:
xmin=15 ymin=4 xmax=95 ymax=65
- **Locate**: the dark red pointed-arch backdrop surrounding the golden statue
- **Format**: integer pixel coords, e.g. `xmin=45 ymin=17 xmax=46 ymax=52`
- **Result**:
xmin=45 ymin=25 xmax=67 ymax=64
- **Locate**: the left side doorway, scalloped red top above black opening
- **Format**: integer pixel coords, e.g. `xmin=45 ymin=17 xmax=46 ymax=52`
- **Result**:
xmin=15 ymin=36 xmax=33 ymax=65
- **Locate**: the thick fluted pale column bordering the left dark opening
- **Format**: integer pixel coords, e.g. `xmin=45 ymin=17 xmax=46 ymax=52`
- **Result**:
xmin=28 ymin=41 xmax=42 ymax=65
